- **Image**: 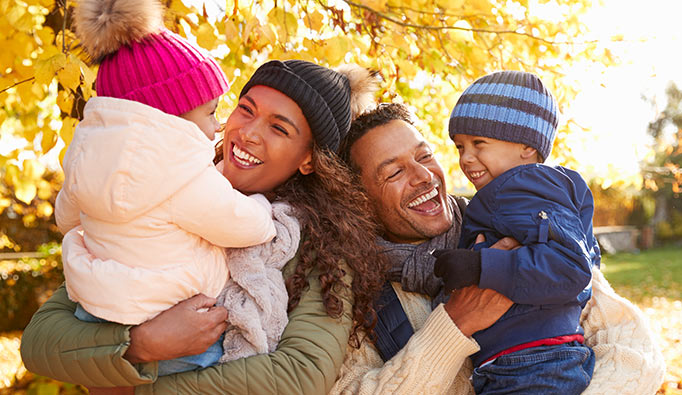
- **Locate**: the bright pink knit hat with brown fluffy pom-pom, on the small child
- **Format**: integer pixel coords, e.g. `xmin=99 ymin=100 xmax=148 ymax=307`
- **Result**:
xmin=75 ymin=0 xmax=228 ymax=115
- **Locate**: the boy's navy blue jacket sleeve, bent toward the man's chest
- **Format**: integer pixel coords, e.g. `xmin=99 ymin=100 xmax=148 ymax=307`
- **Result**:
xmin=472 ymin=166 xmax=599 ymax=305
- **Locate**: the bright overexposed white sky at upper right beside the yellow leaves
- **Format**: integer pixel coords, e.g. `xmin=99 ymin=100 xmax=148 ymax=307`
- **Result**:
xmin=567 ymin=0 xmax=682 ymax=186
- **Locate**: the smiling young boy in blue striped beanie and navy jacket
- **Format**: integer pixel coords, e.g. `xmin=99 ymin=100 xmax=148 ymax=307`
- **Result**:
xmin=434 ymin=71 xmax=600 ymax=394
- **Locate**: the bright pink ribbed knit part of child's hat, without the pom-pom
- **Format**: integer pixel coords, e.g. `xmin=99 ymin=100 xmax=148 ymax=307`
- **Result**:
xmin=95 ymin=29 xmax=228 ymax=115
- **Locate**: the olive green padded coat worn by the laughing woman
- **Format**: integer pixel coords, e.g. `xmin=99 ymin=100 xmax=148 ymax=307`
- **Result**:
xmin=21 ymin=257 xmax=353 ymax=394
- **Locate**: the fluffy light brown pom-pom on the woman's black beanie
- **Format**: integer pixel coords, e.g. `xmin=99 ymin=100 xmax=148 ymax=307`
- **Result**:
xmin=334 ymin=64 xmax=381 ymax=119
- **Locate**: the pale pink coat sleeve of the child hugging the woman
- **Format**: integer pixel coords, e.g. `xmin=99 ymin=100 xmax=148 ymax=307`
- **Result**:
xmin=171 ymin=166 xmax=275 ymax=248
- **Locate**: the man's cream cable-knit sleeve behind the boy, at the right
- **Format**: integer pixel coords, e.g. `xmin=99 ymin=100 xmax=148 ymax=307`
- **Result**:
xmin=581 ymin=269 xmax=665 ymax=395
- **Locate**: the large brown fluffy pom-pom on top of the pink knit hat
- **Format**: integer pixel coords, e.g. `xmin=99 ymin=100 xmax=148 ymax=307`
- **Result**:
xmin=74 ymin=0 xmax=163 ymax=62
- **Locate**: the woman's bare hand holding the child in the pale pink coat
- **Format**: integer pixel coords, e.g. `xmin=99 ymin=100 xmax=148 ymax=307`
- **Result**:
xmin=123 ymin=294 xmax=227 ymax=363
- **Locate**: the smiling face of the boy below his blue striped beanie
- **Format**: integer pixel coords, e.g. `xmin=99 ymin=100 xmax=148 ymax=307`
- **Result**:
xmin=453 ymin=134 xmax=537 ymax=191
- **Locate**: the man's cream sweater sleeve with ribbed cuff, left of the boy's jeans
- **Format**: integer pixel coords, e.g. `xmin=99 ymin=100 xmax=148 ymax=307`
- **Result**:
xmin=331 ymin=304 xmax=479 ymax=395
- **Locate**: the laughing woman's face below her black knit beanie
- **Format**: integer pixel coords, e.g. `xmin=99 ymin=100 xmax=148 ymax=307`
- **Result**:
xmin=223 ymin=85 xmax=313 ymax=193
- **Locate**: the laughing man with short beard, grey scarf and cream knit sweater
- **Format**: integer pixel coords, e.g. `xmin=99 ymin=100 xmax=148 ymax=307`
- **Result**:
xmin=332 ymin=104 xmax=664 ymax=395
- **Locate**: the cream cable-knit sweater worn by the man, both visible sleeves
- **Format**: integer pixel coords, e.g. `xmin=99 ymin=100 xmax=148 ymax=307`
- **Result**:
xmin=330 ymin=270 xmax=665 ymax=395
